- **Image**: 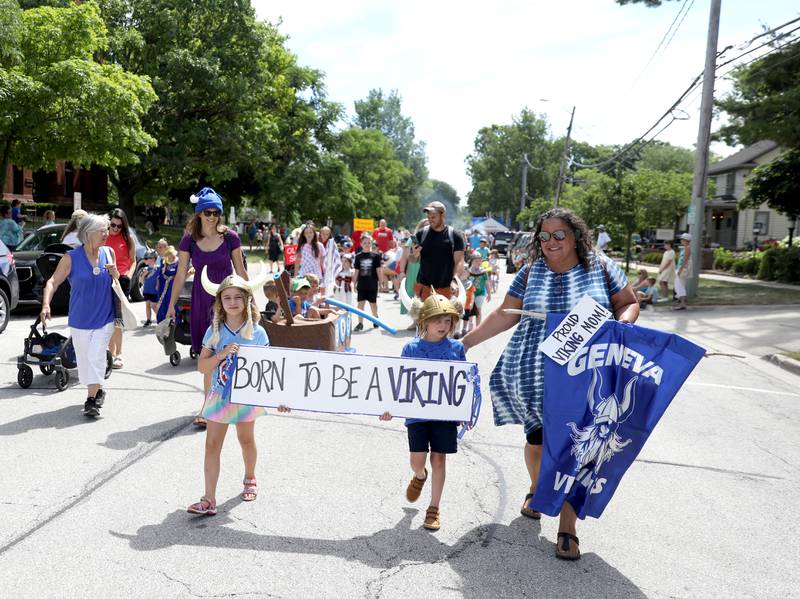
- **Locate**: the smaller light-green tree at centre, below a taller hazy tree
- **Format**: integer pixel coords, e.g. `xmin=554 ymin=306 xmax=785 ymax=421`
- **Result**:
xmin=338 ymin=127 xmax=411 ymax=218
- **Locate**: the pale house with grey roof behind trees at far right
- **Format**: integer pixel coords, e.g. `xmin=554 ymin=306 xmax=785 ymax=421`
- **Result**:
xmin=705 ymin=140 xmax=789 ymax=248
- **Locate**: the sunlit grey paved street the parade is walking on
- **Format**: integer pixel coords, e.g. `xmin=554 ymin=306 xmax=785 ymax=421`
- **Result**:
xmin=0 ymin=276 xmax=800 ymax=598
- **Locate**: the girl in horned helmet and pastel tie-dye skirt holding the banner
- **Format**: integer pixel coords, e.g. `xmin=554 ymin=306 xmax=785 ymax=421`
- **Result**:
xmin=187 ymin=269 xmax=288 ymax=516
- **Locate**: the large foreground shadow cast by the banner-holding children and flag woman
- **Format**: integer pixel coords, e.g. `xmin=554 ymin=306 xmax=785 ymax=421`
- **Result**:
xmin=109 ymin=506 xmax=645 ymax=598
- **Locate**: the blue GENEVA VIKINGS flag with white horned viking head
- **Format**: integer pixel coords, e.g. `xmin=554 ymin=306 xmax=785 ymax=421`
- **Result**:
xmin=533 ymin=313 xmax=705 ymax=518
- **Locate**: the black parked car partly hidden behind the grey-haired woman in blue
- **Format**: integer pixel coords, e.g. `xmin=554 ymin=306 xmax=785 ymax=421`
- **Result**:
xmin=14 ymin=223 xmax=150 ymax=306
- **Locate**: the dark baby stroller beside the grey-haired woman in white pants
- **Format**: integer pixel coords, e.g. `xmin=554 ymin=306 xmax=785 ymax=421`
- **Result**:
xmin=17 ymin=316 xmax=113 ymax=391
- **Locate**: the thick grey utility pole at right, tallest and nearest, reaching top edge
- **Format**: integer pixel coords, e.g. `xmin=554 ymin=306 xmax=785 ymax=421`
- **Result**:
xmin=686 ymin=0 xmax=722 ymax=298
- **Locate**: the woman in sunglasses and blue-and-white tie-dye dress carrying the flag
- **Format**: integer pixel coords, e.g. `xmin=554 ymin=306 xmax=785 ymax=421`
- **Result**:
xmin=462 ymin=208 xmax=639 ymax=560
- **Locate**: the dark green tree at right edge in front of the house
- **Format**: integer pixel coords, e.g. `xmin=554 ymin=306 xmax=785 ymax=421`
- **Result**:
xmin=739 ymin=150 xmax=800 ymax=219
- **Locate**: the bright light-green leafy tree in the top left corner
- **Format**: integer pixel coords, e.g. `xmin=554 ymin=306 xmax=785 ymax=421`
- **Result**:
xmin=0 ymin=0 xmax=156 ymax=187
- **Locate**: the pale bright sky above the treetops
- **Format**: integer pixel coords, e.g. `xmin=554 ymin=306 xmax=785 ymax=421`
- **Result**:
xmin=253 ymin=0 xmax=800 ymax=198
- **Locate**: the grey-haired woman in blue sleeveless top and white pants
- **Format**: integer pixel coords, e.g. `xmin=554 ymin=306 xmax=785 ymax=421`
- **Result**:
xmin=40 ymin=214 xmax=119 ymax=418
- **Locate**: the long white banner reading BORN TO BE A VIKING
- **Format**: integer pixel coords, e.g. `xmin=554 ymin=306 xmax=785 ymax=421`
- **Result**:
xmin=231 ymin=345 xmax=480 ymax=422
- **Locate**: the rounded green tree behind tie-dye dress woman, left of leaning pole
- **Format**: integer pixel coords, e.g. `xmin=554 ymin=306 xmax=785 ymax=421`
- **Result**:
xmin=467 ymin=109 xmax=563 ymax=226
